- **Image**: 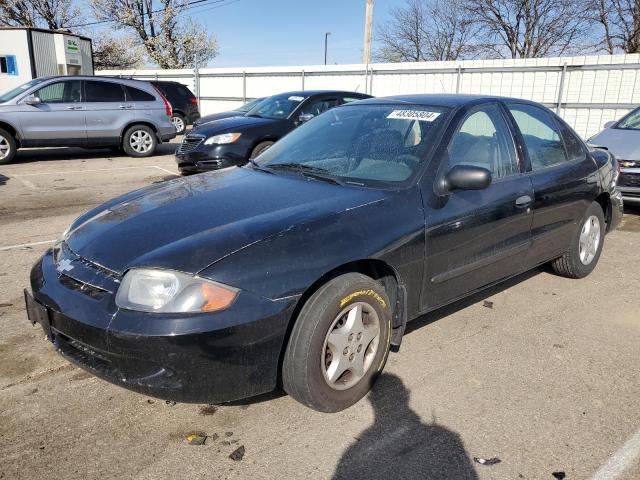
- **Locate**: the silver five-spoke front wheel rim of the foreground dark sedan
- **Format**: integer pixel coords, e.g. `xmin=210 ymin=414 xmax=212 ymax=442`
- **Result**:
xmin=320 ymin=302 xmax=380 ymax=390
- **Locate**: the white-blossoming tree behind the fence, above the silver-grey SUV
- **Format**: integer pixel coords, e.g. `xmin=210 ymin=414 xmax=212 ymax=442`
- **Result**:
xmin=91 ymin=0 xmax=218 ymax=68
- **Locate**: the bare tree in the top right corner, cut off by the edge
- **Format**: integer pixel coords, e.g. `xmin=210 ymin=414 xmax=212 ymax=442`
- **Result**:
xmin=589 ymin=0 xmax=640 ymax=54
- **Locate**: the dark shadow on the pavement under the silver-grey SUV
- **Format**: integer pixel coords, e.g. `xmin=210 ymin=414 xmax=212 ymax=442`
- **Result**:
xmin=13 ymin=143 xmax=180 ymax=164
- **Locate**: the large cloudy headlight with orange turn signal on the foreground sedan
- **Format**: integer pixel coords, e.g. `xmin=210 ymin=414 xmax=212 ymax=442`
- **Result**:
xmin=116 ymin=268 xmax=238 ymax=313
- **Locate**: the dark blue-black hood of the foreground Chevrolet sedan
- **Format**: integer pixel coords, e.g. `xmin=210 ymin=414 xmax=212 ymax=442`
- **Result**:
xmin=66 ymin=168 xmax=388 ymax=273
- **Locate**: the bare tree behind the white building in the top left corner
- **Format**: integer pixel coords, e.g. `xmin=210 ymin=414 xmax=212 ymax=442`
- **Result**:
xmin=0 ymin=0 xmax=80 ymax=30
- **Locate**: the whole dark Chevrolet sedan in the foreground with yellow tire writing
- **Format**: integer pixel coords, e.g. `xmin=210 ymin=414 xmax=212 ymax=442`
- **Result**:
xmin=25 ymin=95 xmax=622 ymax=412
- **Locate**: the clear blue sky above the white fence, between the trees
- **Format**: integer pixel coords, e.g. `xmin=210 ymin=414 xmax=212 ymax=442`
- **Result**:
xmin=92 ymin=0 xmax=404 ymax=67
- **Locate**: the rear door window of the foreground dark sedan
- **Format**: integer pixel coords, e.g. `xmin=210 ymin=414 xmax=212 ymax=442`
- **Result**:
xmin=507 ymin=103 xmax=568 ymax=171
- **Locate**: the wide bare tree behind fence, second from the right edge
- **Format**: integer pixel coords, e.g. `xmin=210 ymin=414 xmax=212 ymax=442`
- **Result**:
xmin=466 ymin=0 xmax=588 ymax=58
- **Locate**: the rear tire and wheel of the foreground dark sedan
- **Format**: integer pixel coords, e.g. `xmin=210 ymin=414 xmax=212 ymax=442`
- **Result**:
xmin=551 ymin=202 xmax=606 ymax=278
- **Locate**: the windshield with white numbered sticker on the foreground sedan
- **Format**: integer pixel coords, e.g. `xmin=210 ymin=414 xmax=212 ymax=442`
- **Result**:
xmin=256 ymin=105 xmax=448 ymax=185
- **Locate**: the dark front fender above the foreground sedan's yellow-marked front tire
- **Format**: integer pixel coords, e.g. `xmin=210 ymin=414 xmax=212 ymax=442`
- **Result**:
xmin=200 ymin=188 xmax=424 ymax=311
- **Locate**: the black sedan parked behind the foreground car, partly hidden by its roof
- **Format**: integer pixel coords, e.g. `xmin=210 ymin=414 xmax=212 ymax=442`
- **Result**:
xmin=176 ymin=90 xmax=370 ymax=173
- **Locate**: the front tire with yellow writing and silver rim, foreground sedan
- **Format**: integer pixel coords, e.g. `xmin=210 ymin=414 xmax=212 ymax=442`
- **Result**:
xmin=282 ymin=273 xmax=392 ymax=413
